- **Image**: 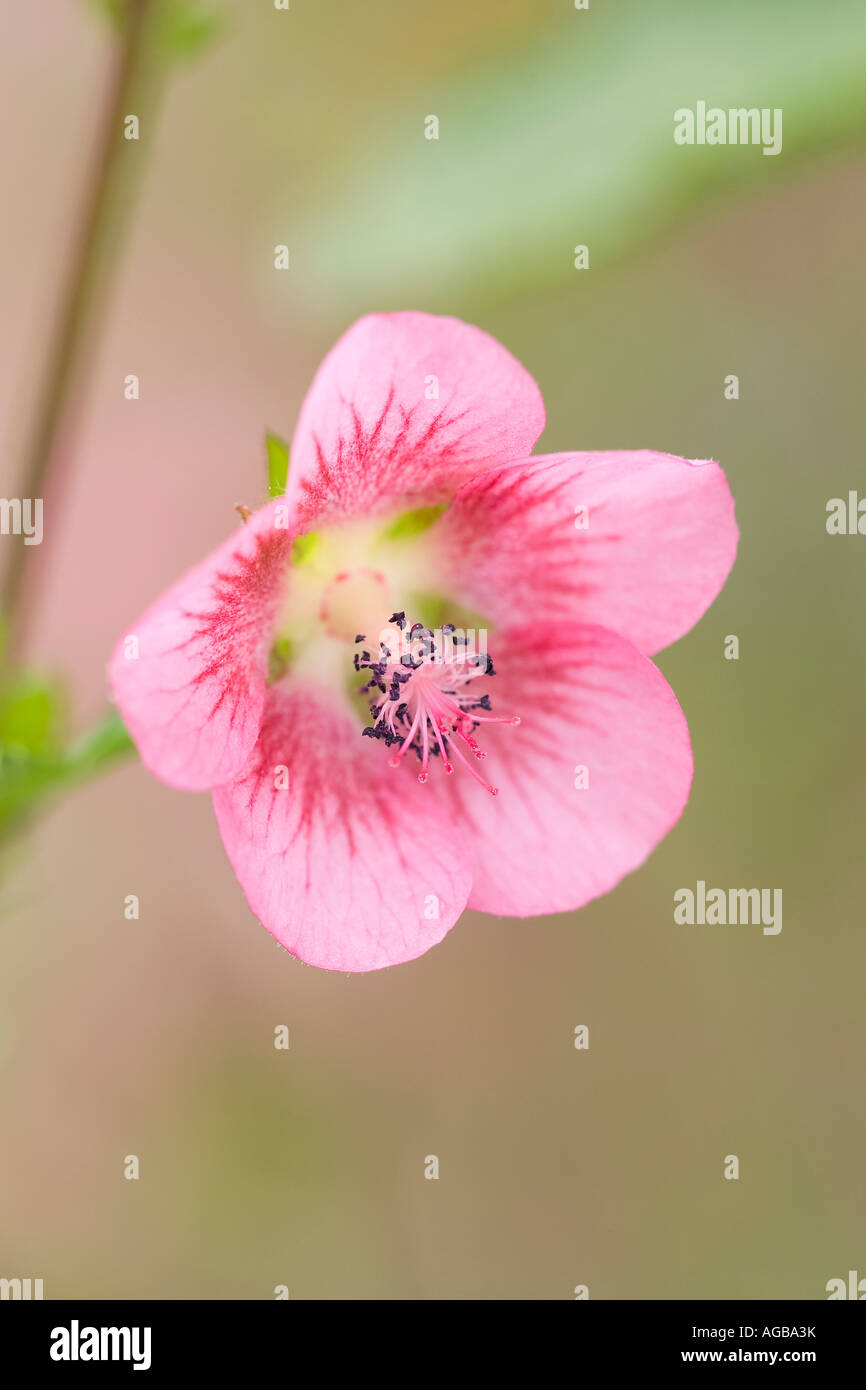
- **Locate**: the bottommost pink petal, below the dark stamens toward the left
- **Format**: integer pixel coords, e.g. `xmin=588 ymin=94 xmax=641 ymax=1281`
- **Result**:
xmin=214 ymin=677 xmax=471 ymax=972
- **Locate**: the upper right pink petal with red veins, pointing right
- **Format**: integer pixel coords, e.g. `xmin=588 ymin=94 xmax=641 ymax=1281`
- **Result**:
xmin=431 ymin=450 xmax=738 ymax=653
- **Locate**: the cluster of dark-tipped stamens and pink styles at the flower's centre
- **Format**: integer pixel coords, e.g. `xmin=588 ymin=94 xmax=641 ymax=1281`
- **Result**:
xmin=354 ymin=613 xmax=520 ymax=796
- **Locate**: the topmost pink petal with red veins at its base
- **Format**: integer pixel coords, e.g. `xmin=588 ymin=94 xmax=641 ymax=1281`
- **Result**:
xmin=288 ymin=313 xmax=545 ymax=525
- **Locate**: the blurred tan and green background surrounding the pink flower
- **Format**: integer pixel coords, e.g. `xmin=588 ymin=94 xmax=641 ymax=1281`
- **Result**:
xmin=0 ymin=0 xmax=866 ymax=1300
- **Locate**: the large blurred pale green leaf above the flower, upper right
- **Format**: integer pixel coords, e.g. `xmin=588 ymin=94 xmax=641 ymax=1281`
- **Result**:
xmin=295 ymin=0 xmax=866 ymax=307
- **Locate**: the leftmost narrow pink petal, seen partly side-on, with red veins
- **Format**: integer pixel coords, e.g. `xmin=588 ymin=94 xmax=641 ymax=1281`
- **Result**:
xmin=110 ymin=499 xmax=296 ymax=791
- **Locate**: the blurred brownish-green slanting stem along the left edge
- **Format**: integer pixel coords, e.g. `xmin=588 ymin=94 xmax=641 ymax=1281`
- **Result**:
xmin=0 ymin=0 xmax=152 ymax=664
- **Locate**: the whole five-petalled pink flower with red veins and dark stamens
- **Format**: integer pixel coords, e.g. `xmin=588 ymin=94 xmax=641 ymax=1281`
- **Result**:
xmin=111 ymin=313 xmax=737 ymax=970
